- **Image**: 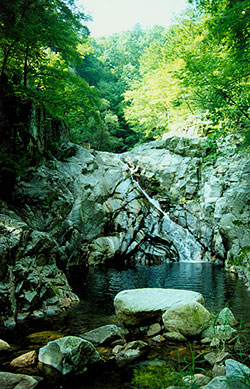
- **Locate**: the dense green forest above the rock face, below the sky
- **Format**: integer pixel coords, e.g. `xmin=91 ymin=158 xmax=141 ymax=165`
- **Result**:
xmin=0 ymin=0 xmax=250 ymax=156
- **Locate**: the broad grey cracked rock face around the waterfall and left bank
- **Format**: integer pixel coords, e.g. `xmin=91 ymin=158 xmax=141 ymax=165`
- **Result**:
xmin=0 ymin=137 xmax=250 ymax=317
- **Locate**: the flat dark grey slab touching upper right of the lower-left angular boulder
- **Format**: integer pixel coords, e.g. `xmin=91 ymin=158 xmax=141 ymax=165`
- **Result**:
xmin=80 ymin=325 xmax=122 ymax=346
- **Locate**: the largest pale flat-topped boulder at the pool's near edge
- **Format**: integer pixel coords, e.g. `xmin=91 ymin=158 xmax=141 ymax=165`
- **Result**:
xmin=114 ymin=288 xmax=204 ymax=326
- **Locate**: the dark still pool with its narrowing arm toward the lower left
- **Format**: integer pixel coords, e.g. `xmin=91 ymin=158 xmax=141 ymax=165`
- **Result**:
xmin=3 ymin=262 xmax=250 ymax=343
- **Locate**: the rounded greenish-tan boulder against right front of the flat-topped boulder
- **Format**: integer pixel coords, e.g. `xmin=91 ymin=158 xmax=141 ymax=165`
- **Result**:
xmin=162 ymin=302 xmax=211 ymax=336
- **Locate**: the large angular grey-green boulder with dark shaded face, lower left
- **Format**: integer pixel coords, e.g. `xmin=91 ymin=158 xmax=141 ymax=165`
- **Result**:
xmin=38 ymin=336 xmax=100 ymax=375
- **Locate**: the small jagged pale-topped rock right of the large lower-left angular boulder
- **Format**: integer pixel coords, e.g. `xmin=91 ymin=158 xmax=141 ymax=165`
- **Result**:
xmin=113 ymin=340 xmax=148 ymax=367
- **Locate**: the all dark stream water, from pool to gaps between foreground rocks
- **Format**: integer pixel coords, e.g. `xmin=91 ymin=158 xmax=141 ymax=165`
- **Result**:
xmin=0 ymin=262 xmax=250 ymax=389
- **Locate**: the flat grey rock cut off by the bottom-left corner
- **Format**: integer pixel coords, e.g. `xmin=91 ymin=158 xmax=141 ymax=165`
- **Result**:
xmin=0 ymin=372 xmax=42 ymax=389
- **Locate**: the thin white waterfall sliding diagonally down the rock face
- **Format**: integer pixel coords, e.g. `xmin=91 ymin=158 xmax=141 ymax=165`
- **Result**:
xmin=123 ymin=158 xmax=203 ymax=262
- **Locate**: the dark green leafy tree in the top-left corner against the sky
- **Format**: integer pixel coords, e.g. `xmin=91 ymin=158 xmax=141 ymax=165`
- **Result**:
xmin=0 ymin=0 xmax=87 ymax=86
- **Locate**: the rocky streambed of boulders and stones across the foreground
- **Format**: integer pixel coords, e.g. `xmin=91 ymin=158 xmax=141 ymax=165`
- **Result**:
xmin=0 ymin=288 xmax=250 ymax=389
